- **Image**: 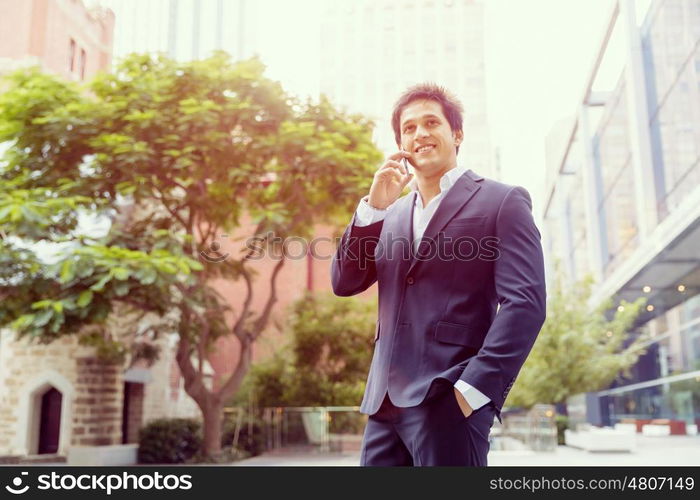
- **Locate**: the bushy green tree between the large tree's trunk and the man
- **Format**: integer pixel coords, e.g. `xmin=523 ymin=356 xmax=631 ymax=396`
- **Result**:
xmin=236 ymin=294 xmax=377 ymax=407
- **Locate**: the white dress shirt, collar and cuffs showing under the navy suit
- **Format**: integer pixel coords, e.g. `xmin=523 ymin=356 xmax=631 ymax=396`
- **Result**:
xmin=355 ymin=166 xmax=491 ymax=410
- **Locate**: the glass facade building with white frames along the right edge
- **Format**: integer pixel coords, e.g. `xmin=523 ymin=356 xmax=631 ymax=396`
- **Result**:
xmin=544 ymin=0 xmax=700 ymax=432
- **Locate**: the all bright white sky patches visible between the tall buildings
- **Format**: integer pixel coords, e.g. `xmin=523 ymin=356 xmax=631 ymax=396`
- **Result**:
xmin=101 ymin=0 xmax=649 ymax=212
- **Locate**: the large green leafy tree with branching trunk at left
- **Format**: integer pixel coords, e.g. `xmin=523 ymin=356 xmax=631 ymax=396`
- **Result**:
xmin=0 ymin=53 xmax=381 ymax=456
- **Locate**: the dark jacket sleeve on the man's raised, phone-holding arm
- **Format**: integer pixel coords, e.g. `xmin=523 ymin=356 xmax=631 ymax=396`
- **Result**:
xmin=331 ymin=215 xmax=384 ymax=297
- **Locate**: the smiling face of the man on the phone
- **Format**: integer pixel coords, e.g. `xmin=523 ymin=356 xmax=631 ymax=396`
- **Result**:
xmin=399 ymin=99 xmax=462 ymax=177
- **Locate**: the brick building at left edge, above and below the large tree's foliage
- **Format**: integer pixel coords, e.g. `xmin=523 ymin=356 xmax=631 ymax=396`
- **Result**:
xmin=0 ymin=0 xmax=198 ymax=462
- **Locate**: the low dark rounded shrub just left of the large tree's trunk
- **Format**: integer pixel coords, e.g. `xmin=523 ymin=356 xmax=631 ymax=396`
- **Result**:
xmin=139 ymin=418 xmax=202 ymax=464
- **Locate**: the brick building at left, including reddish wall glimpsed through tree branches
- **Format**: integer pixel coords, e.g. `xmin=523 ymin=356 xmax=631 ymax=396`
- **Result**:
xmin=0 ymin=0 xmax=358 ymax=464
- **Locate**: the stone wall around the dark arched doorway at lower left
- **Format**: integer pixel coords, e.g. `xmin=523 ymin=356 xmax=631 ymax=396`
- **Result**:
xmin=0 ymin=318 xmax=213 ymax=456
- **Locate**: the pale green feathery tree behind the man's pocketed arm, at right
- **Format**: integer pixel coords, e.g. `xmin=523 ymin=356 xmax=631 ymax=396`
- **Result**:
xmin=508 ymin=274 xmax=645 ymax=407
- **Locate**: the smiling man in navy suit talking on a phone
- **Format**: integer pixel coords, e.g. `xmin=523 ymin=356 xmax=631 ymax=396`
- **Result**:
xmin=331 ymin=84 xmax=545 ymax=466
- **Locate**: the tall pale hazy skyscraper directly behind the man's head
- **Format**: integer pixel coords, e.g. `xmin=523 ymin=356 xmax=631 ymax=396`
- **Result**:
xmin=320 ymin=0 xmax=493 ymax=176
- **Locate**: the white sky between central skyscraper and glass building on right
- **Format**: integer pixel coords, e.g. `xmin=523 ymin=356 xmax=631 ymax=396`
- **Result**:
xmin=484 ymin=0 xmax=611 ymax=205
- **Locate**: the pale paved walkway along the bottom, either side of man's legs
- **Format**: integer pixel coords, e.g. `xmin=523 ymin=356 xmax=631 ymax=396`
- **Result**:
xmin=232 ymin=436 xmax=700 ymax=467
